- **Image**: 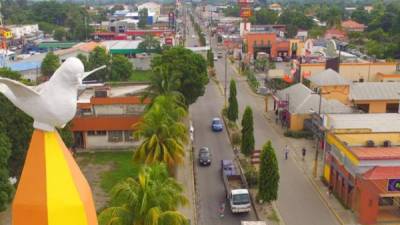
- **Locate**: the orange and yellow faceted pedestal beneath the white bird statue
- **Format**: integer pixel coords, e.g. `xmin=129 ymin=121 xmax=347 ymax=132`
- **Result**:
xmin=12 ymin=130 xmax=98 ymax=225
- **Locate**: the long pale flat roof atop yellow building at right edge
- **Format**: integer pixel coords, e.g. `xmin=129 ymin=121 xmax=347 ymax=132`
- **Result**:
xmin=327 ymin=113 xmax=400 ymax=132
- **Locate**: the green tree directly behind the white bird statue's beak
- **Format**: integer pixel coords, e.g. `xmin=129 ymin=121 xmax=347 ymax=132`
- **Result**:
xmin=88 ymin=46 xmax=110 ymax=81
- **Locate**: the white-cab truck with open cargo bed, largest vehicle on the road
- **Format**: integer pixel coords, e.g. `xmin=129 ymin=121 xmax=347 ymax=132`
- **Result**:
xmin=221 ymin=160 xmax=251 ymax=213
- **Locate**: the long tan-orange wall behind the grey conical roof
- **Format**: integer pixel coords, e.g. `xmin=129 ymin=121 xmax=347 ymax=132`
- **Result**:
xmin=301 ymin=63 xmax=396 ymax=82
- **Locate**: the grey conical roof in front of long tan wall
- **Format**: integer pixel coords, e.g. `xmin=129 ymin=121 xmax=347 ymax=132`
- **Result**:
xmin=308 ymin=69 xmax=350 ymax=86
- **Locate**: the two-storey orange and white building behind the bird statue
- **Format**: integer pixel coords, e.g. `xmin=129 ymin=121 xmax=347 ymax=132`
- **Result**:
xmin=71 ymin=85 xmax=148 ymax=149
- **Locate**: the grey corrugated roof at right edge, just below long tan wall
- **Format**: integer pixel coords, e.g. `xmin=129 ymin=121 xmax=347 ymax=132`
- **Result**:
xmin=350 ymin=82 xmax=400 ymax=100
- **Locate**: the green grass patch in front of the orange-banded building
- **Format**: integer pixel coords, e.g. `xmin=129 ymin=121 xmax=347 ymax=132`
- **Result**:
xmin=78 ymin=151 xmax=141 ymax=193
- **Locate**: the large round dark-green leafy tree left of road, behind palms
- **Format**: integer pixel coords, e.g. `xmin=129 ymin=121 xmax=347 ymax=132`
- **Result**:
xmin=151 ymin=47 xmax=208 ymax=105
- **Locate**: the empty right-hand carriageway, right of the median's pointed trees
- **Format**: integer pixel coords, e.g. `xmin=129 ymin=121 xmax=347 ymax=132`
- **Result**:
xmin=209 ymin=33 xmax=338 ymax=225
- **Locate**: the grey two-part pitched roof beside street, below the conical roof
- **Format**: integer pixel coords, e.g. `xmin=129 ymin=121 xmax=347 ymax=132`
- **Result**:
xmin=277 ymin=83 xmax=352 ymax=114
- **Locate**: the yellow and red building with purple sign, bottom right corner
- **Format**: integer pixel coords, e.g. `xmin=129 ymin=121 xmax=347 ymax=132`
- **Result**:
xmin=323 ymin=113 xmax=400 ymax=224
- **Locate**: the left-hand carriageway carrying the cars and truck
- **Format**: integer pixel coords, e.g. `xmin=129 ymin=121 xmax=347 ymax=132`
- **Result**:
xmin=186 ymin=10 xmax=255 ymax=225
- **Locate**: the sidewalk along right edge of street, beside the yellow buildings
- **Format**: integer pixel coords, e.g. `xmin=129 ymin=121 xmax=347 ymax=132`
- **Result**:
xmin=264 ymin=110 xmax=358 ymax=225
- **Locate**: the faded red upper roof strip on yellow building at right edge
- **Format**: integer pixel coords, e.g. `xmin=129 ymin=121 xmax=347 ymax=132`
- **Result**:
xmin=350 ymin=147 xmax=400 ymax=160
